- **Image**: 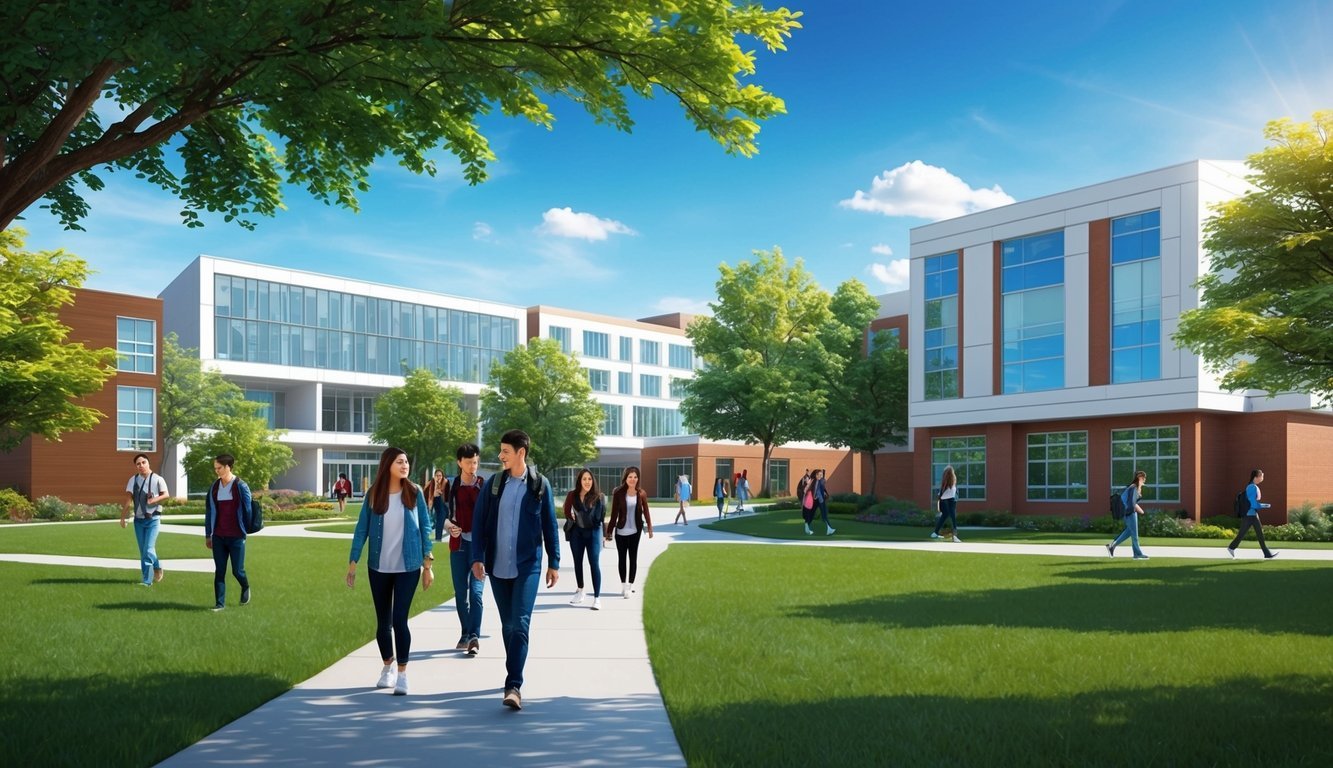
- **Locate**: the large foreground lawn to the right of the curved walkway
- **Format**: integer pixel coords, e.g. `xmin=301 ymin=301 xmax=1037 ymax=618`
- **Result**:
xmin=644 ymin=544 xmax=1333 ymax=768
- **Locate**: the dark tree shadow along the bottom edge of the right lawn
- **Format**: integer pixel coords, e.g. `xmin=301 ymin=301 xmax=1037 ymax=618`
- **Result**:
xmin=668 ymin=676 xmax=1333 ymax=768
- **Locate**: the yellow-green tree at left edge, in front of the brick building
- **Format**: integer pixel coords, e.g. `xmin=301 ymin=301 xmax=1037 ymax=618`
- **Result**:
xmin=0 ymin=229 xmax=116 ymax=451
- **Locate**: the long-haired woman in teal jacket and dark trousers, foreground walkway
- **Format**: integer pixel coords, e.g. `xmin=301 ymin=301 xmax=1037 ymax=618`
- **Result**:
xmin=347 ymin=447 xmax=435 ymax=696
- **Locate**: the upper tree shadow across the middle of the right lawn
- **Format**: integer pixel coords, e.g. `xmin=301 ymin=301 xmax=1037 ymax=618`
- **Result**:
xmin=788 ymin=564 xmax=1333 ymax=637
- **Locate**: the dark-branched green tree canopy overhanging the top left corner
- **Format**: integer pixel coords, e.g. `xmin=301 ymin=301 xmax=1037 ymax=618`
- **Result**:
xmin=0 ymin=0 xmax=800 ymax=229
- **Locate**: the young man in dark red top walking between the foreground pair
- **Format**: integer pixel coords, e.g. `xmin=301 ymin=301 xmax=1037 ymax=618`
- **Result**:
xmin=444 ymin=443 xmax=487 ymax=656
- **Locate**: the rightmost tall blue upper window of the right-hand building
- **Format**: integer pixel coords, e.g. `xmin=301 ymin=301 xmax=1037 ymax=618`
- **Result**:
xmin=1110 ymin=211 xmax=1162 ymax=383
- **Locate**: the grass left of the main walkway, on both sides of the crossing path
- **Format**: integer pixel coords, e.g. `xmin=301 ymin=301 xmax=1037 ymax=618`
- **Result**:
xmin=0 ymin=523 xmax=453 ymax=767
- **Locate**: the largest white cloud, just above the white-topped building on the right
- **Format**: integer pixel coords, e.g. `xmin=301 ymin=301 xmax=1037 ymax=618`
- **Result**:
xmin=838 ymin=160 xmax=1014 ymax=221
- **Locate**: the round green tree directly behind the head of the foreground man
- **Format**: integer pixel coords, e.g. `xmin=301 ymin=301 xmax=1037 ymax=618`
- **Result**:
xmin=481 ymin=339 xmax=603 ymax=472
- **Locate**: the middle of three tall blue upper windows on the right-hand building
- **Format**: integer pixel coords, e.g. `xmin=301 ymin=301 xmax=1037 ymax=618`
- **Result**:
xmin=1000 ymin=229 xmax=1065 ymax=392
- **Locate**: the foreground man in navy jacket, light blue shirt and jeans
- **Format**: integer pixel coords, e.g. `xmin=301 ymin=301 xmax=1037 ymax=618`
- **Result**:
xmin=472 ymin=429 xmax=560 ymax=709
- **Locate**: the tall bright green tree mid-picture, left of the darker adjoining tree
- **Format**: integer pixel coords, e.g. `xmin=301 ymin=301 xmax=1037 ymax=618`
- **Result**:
xmin=680 ymin=248 xmax=837 ymax=496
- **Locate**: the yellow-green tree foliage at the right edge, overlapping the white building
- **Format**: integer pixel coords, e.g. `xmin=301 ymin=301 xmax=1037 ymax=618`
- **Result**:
xmin=1174 ymin=111 xmax=1333 ymax=404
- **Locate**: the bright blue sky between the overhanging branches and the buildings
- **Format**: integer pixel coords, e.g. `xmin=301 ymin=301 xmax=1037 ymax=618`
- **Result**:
xmin=19 ymin=0 xmax=1333 ymax=317
